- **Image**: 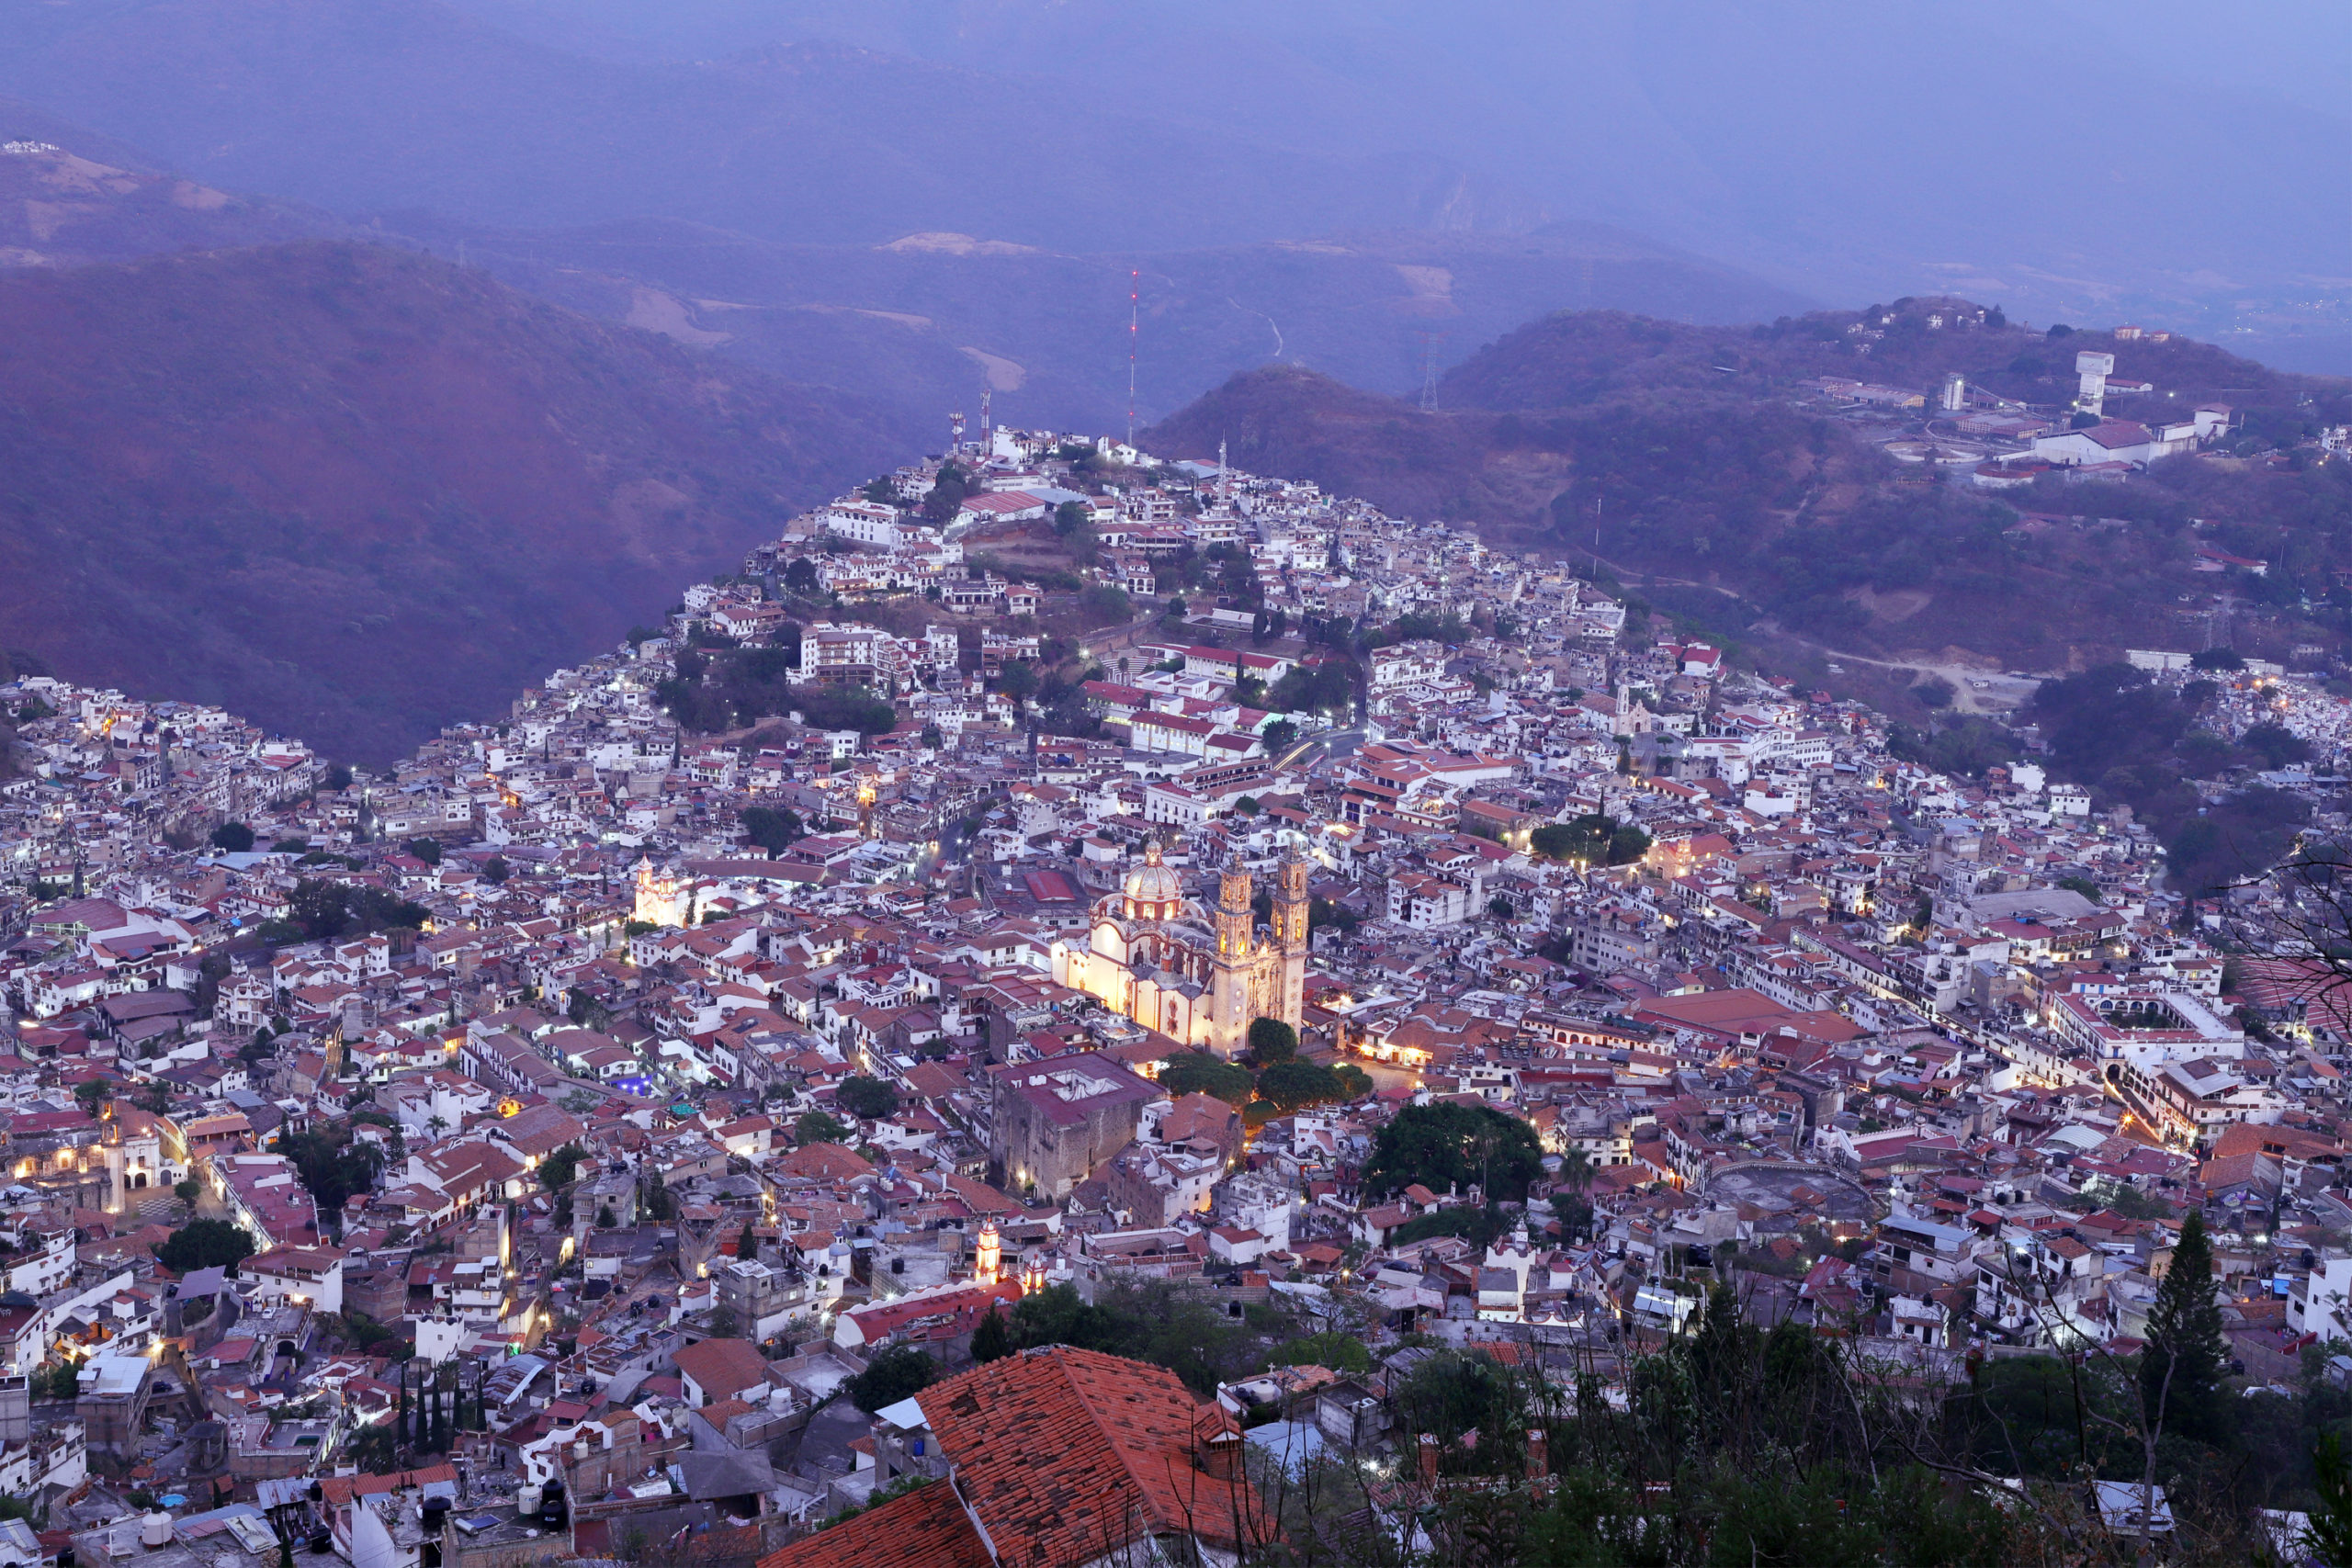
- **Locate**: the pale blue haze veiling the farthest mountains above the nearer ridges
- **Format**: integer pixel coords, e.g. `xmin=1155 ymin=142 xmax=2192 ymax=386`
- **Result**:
xmin=0 ymin=0 xmax=2352 ymax=378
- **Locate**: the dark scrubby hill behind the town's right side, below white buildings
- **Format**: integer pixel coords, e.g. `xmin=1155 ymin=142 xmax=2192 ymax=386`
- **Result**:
xmin=1148 ymin=301 xmax=2352 ymax=700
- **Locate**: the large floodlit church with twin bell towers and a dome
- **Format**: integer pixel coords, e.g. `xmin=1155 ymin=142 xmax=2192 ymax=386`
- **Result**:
xmin=1054 ymin=840 xmax=1307 ymax=1058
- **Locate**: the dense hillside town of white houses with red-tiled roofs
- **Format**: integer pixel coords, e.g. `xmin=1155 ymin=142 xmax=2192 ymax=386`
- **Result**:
xmin=0 ymin=423 xmax=2352 ymax=1568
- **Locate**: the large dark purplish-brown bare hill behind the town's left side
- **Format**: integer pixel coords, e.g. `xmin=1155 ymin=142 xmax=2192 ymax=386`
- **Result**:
xmin=0 ymin=243 xmax=912 ymax=761
